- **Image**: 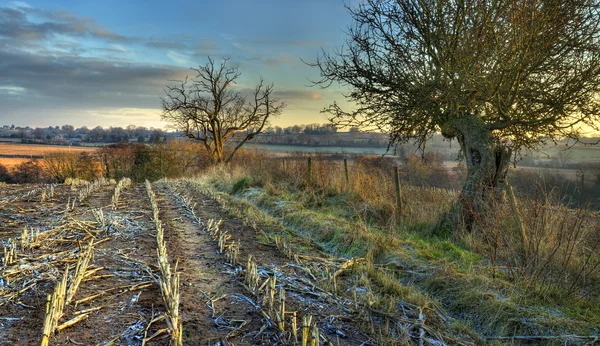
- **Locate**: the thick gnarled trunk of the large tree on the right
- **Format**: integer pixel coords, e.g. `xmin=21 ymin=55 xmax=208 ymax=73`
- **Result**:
xmin=440 ymin=116 xmax=512 ymax=232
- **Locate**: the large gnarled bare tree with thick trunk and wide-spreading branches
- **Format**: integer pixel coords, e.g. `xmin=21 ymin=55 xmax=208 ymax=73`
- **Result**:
xmin=314 ymin=0 xmax=600 ymax=229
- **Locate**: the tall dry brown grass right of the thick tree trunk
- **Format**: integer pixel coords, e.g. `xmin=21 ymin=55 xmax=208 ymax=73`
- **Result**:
xmin=463 ymin=187 xmax=600 ymax=301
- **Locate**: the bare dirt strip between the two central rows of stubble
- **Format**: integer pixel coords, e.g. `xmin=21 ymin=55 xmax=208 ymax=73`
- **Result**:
xmin=156 ymin=182 xmax=268 ymax=345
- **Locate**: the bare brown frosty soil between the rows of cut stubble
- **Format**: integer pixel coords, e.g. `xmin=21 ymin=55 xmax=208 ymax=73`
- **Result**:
xmin=0 ymin=183 xmax=372 ymax=346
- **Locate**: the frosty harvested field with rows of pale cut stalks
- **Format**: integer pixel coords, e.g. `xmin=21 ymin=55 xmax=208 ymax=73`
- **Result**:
xmin=0 ymin=180 xmax=474 ymax=345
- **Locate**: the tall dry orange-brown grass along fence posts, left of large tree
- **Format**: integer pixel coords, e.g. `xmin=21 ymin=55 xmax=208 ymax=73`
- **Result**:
xmin=229 ymin=151 xmax=457 ymax=231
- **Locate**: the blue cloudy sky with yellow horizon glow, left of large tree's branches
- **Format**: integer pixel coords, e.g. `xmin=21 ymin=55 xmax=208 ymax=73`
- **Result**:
xmin=0 ymin=0 xmax=352 ymax=128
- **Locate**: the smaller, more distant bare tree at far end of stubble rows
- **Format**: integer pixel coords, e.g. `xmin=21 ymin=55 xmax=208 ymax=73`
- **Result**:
xmin=162 ymin=57 xmax=285 ymax=163
